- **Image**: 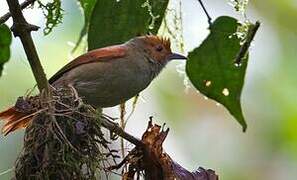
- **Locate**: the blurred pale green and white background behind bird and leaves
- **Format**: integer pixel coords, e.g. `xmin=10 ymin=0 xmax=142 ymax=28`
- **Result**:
xmin=0 ymin=0 xmax=297 ymax=180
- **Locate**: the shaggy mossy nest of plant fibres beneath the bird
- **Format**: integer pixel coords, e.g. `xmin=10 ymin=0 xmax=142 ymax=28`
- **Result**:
xmin=14 ymin=89 xmax=117 ymax=180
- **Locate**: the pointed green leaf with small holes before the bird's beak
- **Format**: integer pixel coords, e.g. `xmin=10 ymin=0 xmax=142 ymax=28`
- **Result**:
xmin=186 ymin=16 xmax=248 ymax=131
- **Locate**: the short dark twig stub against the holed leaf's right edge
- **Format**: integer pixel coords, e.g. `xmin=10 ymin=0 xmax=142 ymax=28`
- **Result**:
xmin=234 ymin=21 xmax=260 ymax=65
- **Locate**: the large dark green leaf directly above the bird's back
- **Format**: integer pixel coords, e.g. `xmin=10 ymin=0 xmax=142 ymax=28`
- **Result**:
xmin=88 ymin=0 xmax=168 ymax=50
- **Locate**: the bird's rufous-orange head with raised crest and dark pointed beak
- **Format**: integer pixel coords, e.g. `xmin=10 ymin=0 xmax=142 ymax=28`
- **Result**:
xmin=129 ymin=35 xmax=187 ymax=65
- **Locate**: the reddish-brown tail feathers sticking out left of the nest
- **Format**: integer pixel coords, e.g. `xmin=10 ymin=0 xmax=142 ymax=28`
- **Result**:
xmin=0 ymin=107 xmax=33 ymax=136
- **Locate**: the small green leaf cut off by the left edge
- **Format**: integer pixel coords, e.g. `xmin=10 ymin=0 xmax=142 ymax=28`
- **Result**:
xmin=0 ymin=24 xmax=11 ymax=76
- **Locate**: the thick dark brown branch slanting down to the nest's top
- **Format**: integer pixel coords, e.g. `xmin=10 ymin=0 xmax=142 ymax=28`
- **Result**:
xmin=6 ymin=0 xmax=49 ymax=96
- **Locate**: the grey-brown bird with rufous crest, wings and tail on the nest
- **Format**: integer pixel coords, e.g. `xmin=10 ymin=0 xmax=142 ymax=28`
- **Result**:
xmin=0 ymin=35 xmax=187 ymax=135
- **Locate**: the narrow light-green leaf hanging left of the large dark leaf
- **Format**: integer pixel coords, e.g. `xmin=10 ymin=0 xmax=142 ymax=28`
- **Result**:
xmin=73 ymin=0 xmax=97 ymax=51
